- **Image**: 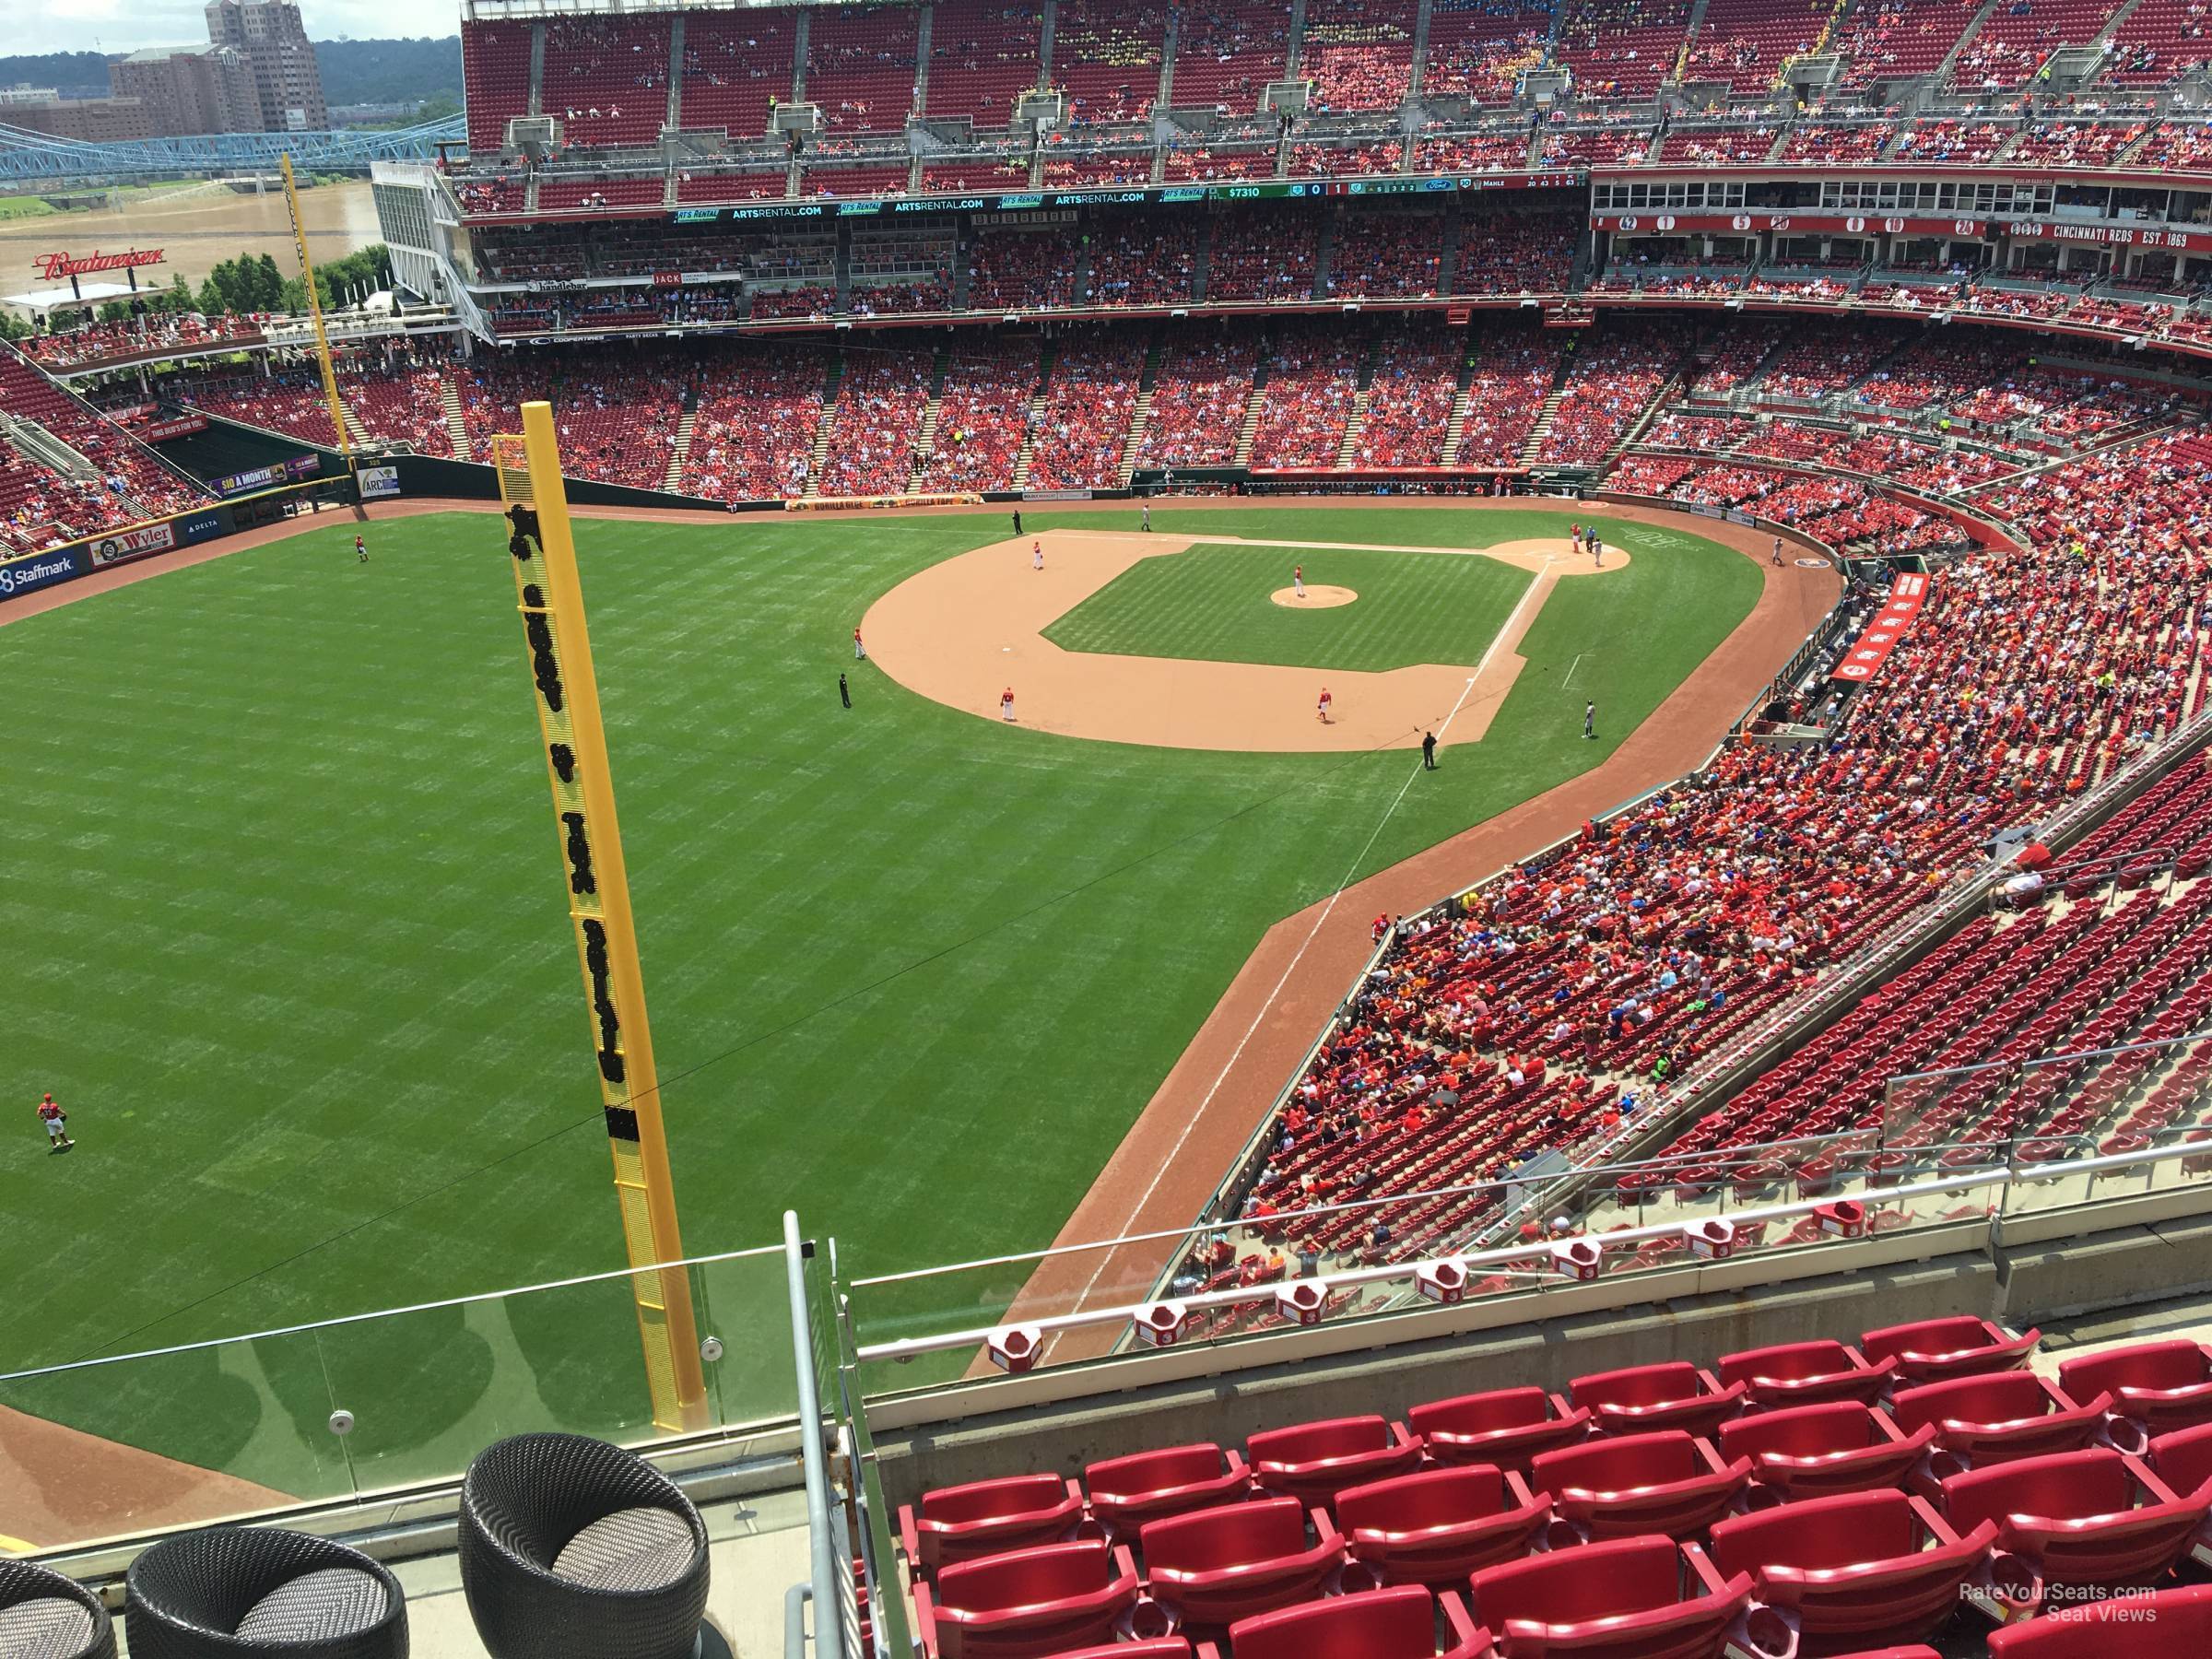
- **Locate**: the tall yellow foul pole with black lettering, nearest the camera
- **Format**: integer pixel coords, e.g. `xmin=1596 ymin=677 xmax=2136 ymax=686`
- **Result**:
xmin=493 ymin=403 xmax=708 ymax=1431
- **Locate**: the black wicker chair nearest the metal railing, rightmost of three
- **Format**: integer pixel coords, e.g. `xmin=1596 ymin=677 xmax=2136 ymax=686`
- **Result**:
xmin=460 ymin=1433 xmax=708 ymax=1659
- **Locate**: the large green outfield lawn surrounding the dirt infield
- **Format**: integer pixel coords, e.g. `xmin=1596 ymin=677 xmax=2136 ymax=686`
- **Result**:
xmin=0 ymin=507 xmax=1760 ymax=1484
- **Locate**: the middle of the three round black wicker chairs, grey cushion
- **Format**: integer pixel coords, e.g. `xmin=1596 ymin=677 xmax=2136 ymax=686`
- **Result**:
xmin=124 ymin=1526 xmax=407 ymax=1659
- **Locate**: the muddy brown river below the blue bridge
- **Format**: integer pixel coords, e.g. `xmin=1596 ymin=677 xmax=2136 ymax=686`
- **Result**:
xmin=0 ymin=179 xmax=381 ymax=310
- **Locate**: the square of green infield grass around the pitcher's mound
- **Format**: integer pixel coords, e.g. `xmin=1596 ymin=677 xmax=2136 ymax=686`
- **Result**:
xmin=1044 ymin=544 xmax=1535 ymax=673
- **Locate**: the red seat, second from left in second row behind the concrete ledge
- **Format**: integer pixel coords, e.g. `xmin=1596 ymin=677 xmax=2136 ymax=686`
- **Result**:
xmin=1137 ymin=1498 xmax=1345 ymax=1628
